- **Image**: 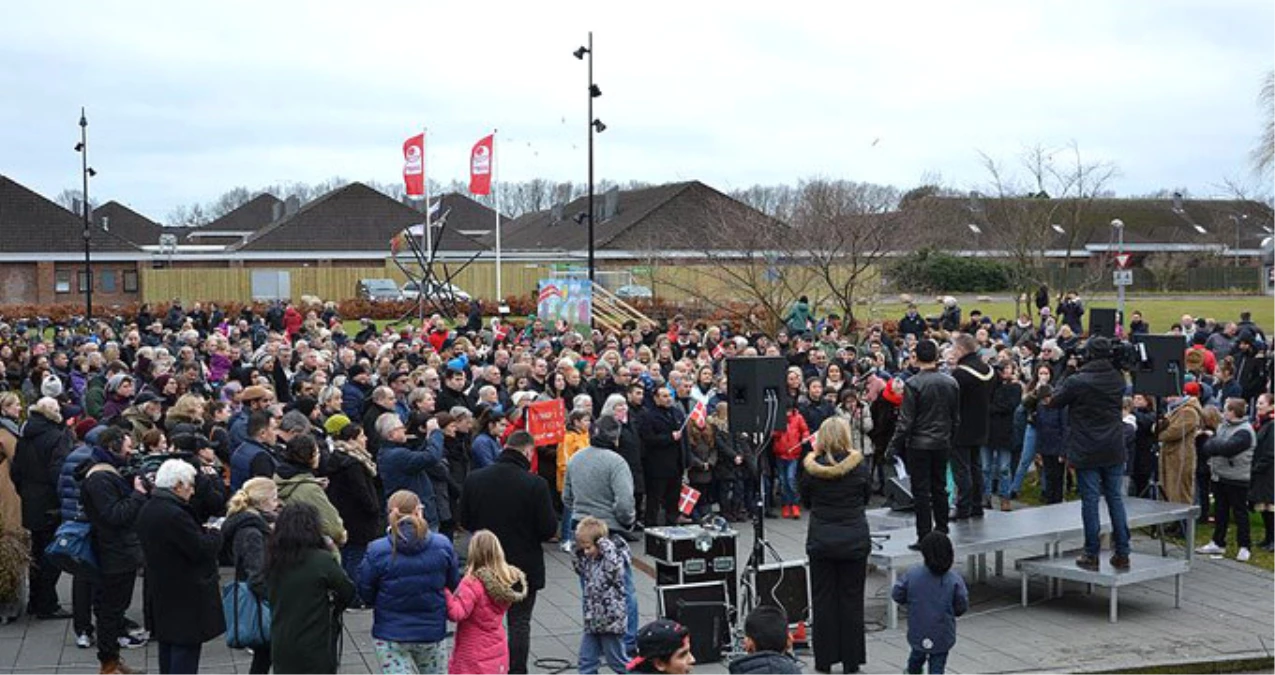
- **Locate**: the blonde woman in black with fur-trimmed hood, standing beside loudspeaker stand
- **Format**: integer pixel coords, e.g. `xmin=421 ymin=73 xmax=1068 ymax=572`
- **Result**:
xmin=801 ymin=417 xmax=872 ymax=672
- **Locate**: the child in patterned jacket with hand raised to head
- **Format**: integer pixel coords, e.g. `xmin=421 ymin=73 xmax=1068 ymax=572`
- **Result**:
xmin=571 ymin=516 xmax=630 ymax=675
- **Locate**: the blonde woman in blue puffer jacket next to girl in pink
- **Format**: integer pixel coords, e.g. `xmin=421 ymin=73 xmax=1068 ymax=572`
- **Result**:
xmin=358 ymin=490 xmax=460 ymax=675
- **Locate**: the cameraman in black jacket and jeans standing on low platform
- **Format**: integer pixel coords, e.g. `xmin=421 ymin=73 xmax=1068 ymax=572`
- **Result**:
xmin=1047 ymin=336 xmax=1128 ymax=570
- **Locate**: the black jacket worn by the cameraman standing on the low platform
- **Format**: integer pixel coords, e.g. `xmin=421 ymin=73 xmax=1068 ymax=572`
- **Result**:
xmin=1049 ymin=360 xmax=1125 ymax=468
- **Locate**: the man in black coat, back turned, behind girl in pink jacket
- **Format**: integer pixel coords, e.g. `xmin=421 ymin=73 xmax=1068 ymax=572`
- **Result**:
xmin=459 ymin=431 xmax=558 ymax=674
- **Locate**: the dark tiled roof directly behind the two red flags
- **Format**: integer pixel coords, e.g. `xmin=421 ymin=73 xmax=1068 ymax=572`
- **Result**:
xmin=236 ymin=182 xmax=484 ymax=255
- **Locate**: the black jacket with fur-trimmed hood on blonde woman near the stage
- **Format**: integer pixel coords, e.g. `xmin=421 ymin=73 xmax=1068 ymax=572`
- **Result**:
xmin=799 ymin=452 xmax=872 ymax=560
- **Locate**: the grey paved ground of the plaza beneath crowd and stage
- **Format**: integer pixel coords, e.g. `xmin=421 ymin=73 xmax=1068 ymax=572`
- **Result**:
xmin=0 ymin=502 xmax=1275 ymax=675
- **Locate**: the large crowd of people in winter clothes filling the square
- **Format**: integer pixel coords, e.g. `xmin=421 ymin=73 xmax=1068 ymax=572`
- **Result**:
xmin=0 ymin=295 xmax=1275 ymax=674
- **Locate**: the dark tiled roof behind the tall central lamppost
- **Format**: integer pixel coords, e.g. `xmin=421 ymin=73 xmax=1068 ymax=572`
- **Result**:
xmin=501 ymin=181 xmax=765 ymax=251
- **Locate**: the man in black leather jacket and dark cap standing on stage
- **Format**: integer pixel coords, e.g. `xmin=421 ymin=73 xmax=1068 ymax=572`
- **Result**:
xmin=886 ymin=339 xmax=960 ymax=550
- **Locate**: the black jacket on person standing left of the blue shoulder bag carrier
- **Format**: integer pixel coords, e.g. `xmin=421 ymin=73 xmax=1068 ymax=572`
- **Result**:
xmin=9 ymin=413 xmax=71 ymax=531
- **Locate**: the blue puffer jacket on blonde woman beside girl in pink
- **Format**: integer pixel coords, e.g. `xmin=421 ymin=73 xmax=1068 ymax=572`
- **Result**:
xmin=358 ymin=522 xmax=460 ymax=643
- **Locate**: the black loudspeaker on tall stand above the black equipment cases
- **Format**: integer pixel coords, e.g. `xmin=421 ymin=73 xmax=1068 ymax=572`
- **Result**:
xmin=725 ymin=356 xmax=788 ymax=434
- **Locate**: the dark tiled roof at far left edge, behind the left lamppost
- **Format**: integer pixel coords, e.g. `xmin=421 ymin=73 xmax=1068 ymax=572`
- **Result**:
xmin=0 ymin=176 xmax=138 ymax=253
